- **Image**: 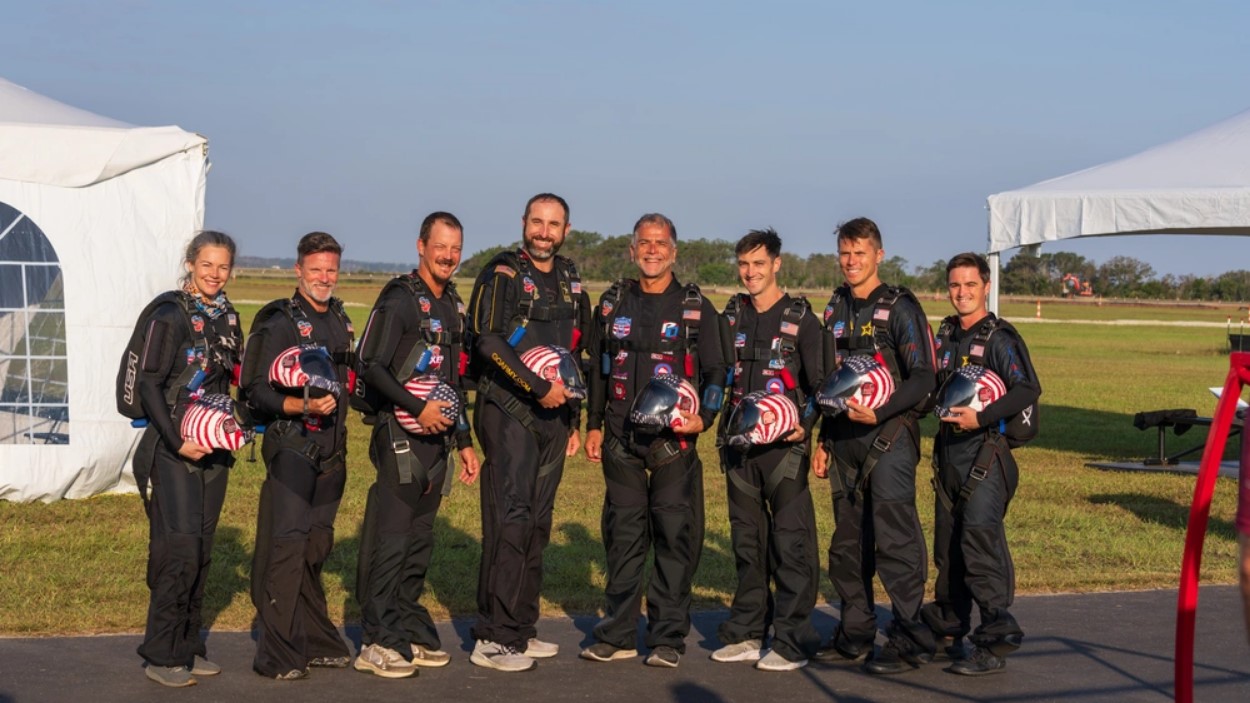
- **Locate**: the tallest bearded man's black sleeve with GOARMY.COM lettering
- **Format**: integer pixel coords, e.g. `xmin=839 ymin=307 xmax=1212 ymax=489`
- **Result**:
xmin=469 ymin=264 xmax=551 ymax=398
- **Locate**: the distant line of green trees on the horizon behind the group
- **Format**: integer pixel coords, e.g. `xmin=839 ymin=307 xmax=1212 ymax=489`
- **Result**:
xmin=460 ymin=230 xmax=1250 ymax=301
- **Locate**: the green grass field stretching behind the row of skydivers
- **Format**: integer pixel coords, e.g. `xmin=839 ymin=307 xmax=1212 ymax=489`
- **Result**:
xmin=0 ymin=279 xmax=1244 ymax=635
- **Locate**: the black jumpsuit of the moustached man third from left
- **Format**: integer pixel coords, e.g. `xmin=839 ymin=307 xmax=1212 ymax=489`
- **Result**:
xmin=356 ymin=271 xmax=473 ymax=660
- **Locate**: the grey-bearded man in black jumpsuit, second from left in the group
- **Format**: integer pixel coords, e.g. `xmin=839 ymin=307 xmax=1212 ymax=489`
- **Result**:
xmin=245 ymin=231 xmax=353 ymax=680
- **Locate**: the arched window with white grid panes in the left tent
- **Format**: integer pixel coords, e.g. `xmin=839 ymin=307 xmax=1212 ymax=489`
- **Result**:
xmin=0 ymin=203 xmax=70 ymax=444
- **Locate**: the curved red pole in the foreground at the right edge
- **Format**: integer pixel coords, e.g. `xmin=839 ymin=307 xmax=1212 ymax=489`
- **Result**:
xmin=1174 ymin=353 xmax=1250 ymax=703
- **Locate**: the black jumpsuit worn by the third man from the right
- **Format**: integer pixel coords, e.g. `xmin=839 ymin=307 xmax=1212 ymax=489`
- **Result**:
xmin=719 ymin=295 xmax=824 ymax=662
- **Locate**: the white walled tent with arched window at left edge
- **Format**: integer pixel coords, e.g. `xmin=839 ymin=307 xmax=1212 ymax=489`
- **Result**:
xmin=0 ymin=79 xmax=209 ymax=500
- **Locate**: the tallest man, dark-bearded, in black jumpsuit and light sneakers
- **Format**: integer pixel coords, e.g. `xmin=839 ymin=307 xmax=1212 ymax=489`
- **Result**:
xmin=468 ymin=193 xmax=589 ymax=672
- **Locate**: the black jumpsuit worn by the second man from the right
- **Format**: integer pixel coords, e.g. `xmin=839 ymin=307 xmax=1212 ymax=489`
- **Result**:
xmin=820 ymin=284 xmax=935 ymax=654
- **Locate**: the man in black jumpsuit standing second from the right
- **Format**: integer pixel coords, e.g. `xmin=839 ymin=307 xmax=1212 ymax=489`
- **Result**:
xmin=813 ymin=218 xmax=934 ymax=674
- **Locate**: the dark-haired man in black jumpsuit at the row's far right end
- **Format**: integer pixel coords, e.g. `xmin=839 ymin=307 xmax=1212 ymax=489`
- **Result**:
xmin=924 ymin=254 xmax=1041 ymax=675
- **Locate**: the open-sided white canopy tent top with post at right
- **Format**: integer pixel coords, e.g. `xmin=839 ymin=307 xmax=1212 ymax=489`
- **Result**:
xmin=989 ymin=104 xmax=1250 ymax=310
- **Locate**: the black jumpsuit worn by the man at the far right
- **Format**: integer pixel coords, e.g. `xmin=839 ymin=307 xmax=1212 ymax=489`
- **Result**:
xmin=924 ymin=313 xmax=1041 ymax=657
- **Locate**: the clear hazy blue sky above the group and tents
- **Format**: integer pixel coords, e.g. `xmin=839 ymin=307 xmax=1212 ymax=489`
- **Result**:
xmin=9 ymin=0 xmax=1250 ymax=274
